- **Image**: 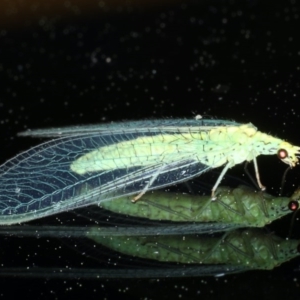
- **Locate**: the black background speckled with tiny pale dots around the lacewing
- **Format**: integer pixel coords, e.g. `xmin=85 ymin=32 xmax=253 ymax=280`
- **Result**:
xmin=0 ymin=0 xmax=300 ymax=300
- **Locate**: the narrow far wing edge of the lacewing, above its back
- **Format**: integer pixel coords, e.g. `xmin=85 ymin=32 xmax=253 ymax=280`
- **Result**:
xmin=18 ymin=119 xmax=241 ymax=138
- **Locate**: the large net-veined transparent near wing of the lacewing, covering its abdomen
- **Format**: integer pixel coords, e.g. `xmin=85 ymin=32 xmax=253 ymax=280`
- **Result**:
xmin=0 ymin=126 xmax=239 ymax=224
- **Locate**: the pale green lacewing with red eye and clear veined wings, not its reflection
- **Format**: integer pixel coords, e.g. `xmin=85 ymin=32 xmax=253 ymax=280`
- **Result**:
xmin=0 ymin=119 xmax=299 ymax=224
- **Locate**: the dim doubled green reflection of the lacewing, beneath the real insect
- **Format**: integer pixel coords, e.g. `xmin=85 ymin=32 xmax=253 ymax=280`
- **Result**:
xmin=0 ymin=179 xmax=299 ymax=278
